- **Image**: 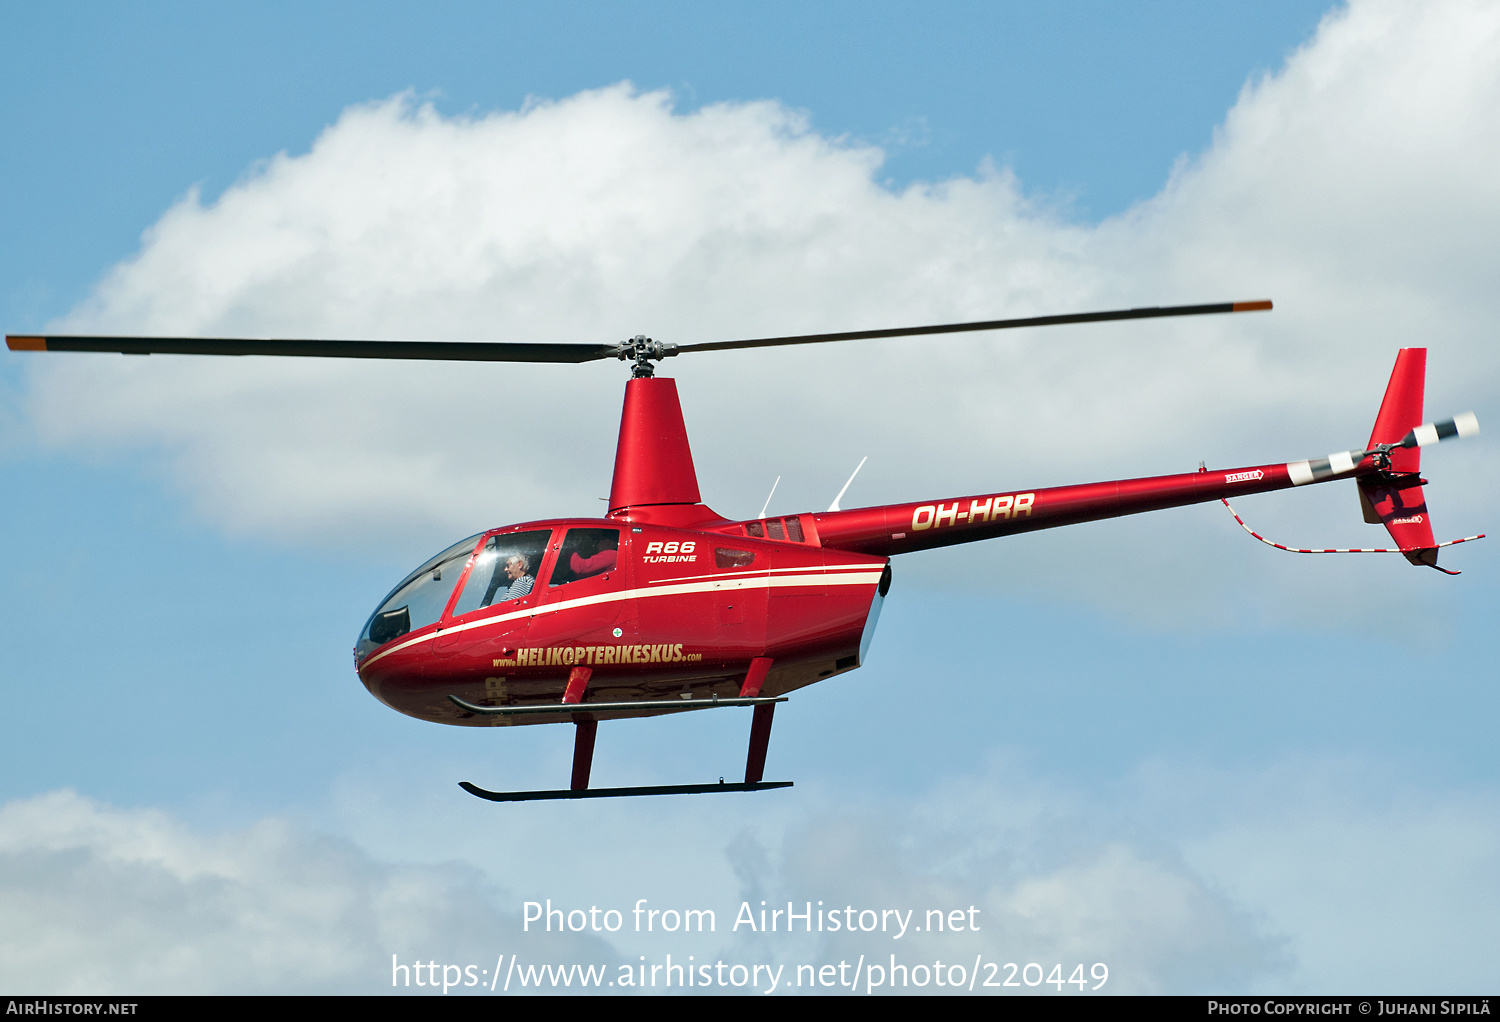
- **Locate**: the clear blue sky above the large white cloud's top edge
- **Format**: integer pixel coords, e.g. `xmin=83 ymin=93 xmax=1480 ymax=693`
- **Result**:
xmin=0 ymin=3 xmax=1326 ymax=329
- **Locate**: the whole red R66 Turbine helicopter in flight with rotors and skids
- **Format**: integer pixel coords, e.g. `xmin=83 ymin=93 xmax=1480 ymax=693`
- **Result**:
xmin=6 ymin=302 xmax=1482 ymax=801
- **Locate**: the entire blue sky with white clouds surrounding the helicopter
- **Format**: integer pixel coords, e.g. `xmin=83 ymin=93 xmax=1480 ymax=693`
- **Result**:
xmin=0 ymin=3 xmax=1500 ymax=993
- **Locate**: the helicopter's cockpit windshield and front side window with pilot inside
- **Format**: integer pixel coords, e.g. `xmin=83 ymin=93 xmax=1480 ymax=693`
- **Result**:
xmin=354 ymin=528 xmax=552 ymax=657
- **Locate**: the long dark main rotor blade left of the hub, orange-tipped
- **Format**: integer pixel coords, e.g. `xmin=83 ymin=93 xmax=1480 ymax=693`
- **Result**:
xmin=5 ymin=335 xmax=620 ymax=362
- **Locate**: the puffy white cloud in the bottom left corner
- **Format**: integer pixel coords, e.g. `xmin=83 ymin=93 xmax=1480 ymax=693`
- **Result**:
xmin=0 ymin=791 xmax=608 ymax=993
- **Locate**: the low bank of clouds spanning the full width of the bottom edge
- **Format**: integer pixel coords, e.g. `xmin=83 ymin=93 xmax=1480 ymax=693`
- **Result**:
xmin=11 ymin=758 xmax=1500 ymax=993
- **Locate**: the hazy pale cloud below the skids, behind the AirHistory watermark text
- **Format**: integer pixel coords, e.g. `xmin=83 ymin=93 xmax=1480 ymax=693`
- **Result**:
xmin=328 ymin=762 xmax=1292 ymax=993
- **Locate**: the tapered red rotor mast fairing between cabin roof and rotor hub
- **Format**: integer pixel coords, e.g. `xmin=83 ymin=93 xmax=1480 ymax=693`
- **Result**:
xmin=609 ymin=377 xmax=699 ymax=513
